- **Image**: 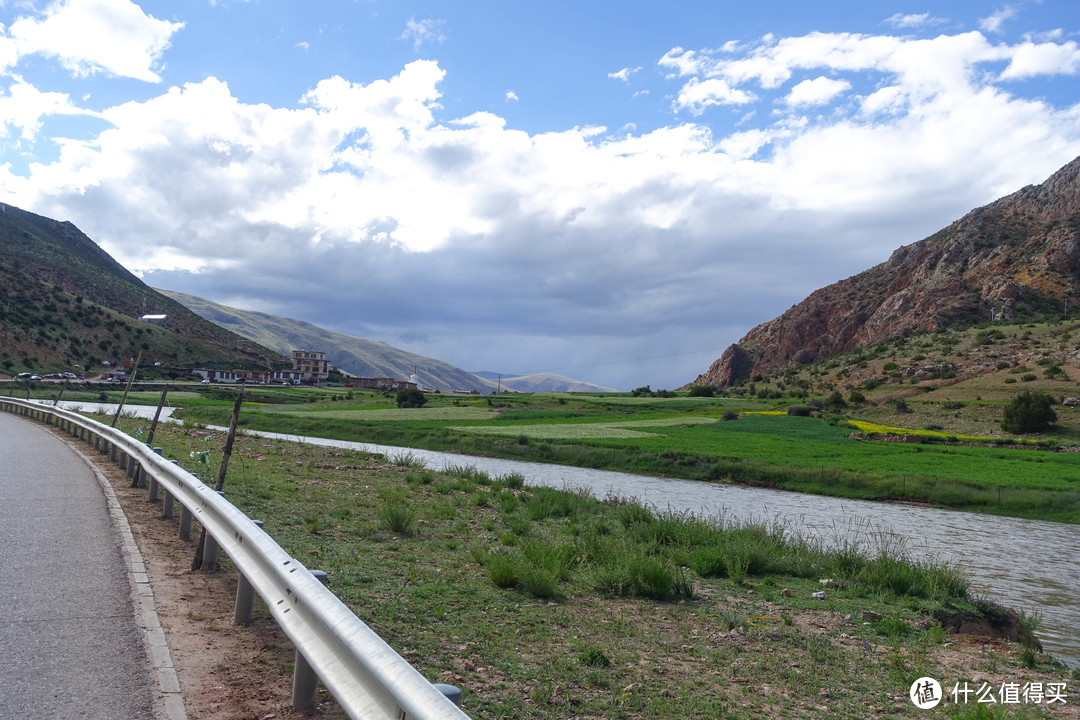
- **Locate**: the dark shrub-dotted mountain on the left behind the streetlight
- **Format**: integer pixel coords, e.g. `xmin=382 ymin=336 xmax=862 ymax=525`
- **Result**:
xmin=0 ymin=205 xmax=291 ymax=372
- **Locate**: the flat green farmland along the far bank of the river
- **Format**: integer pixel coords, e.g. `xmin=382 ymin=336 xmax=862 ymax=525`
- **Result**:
xmin=152 ymin=389 xmax=1080 ymax=522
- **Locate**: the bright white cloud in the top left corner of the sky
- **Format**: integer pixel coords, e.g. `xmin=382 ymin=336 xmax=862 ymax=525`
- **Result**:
xmin=0 ymin=0 xmax=184 ymax=82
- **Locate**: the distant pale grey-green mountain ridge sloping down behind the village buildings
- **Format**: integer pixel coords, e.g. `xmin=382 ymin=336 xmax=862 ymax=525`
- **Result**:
xmin=159 ymin=290 xmax=496 ymax=393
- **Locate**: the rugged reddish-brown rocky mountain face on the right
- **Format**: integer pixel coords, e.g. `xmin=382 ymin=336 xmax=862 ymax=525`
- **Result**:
xmin=691 ymin=158 xmax=1080 ymax=388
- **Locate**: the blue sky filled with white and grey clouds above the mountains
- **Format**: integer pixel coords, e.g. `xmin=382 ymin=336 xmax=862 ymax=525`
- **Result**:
xmin=0 ymin=0 xmax=1080 ymax=389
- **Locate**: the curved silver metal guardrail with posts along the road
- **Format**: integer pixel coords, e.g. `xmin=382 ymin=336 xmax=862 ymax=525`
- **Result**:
xmin=0 ymin=397 xmax=468 ymax=720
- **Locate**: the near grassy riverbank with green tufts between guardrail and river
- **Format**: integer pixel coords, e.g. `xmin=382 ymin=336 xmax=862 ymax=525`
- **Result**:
xmin=132 ymin=426 xmax=1080 ymax=718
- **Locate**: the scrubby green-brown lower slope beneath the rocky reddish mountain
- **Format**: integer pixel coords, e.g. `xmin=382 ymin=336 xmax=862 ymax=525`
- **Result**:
xmin=725 ymin=318 xmax=1080 ymax=443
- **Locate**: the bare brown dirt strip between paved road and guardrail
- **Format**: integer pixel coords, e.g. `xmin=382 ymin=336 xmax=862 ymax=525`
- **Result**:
xmin=58 ymin=427 xmax=346 ymax=720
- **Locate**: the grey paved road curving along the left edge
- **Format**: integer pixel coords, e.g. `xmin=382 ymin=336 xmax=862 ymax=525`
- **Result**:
xmin=0 ymin=413 xmax=154 ymax=720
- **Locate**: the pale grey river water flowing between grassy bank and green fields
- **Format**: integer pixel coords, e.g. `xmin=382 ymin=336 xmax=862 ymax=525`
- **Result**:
xmin=39 ymin=403 xmax=1080 ymax=667
